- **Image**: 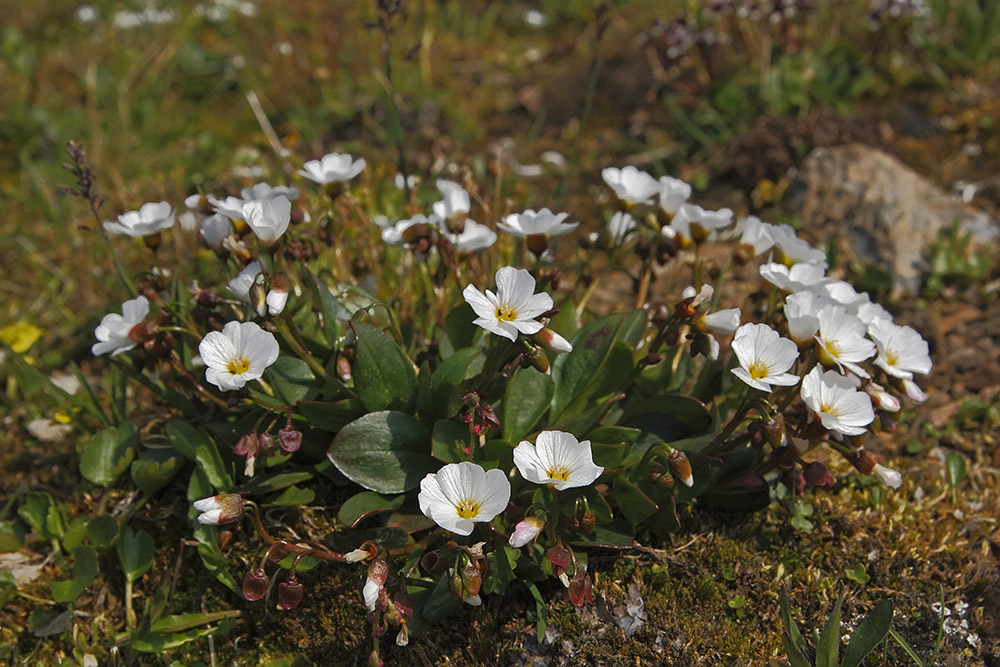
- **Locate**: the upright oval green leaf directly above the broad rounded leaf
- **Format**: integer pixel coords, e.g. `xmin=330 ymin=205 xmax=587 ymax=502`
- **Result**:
xmin=351 ymin=322 xmax=417 ymax=412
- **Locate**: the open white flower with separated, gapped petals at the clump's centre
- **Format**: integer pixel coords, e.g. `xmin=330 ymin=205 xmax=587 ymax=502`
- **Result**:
xmin=462 ymin=266 xmax=552 ymax=340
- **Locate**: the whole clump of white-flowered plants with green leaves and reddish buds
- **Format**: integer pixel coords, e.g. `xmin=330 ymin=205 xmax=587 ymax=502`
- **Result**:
xmin=1 ymin=138 xmax=931 ymax=659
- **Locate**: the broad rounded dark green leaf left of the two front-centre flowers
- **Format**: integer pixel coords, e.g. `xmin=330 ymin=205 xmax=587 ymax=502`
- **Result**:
xmin=326 ymin=410 xmax=440 ymax=493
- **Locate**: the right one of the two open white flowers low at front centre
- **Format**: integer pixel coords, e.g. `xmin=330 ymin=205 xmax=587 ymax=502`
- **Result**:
xmin=514 ymin=431 xmax=604 ymax=491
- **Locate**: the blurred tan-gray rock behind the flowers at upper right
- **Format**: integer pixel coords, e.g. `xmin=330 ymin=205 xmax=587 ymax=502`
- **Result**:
xmin=788 ymin=144 xmax=1000 ymax=293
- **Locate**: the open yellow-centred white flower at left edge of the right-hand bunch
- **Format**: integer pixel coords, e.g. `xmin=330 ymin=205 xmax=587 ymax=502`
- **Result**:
xmin=732 ymin=324 xmax=799 ymax=391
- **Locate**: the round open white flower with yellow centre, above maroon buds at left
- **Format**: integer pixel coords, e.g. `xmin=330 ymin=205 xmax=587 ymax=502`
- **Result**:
xmin=198 ymin=322 xmax=278 ymax=391
